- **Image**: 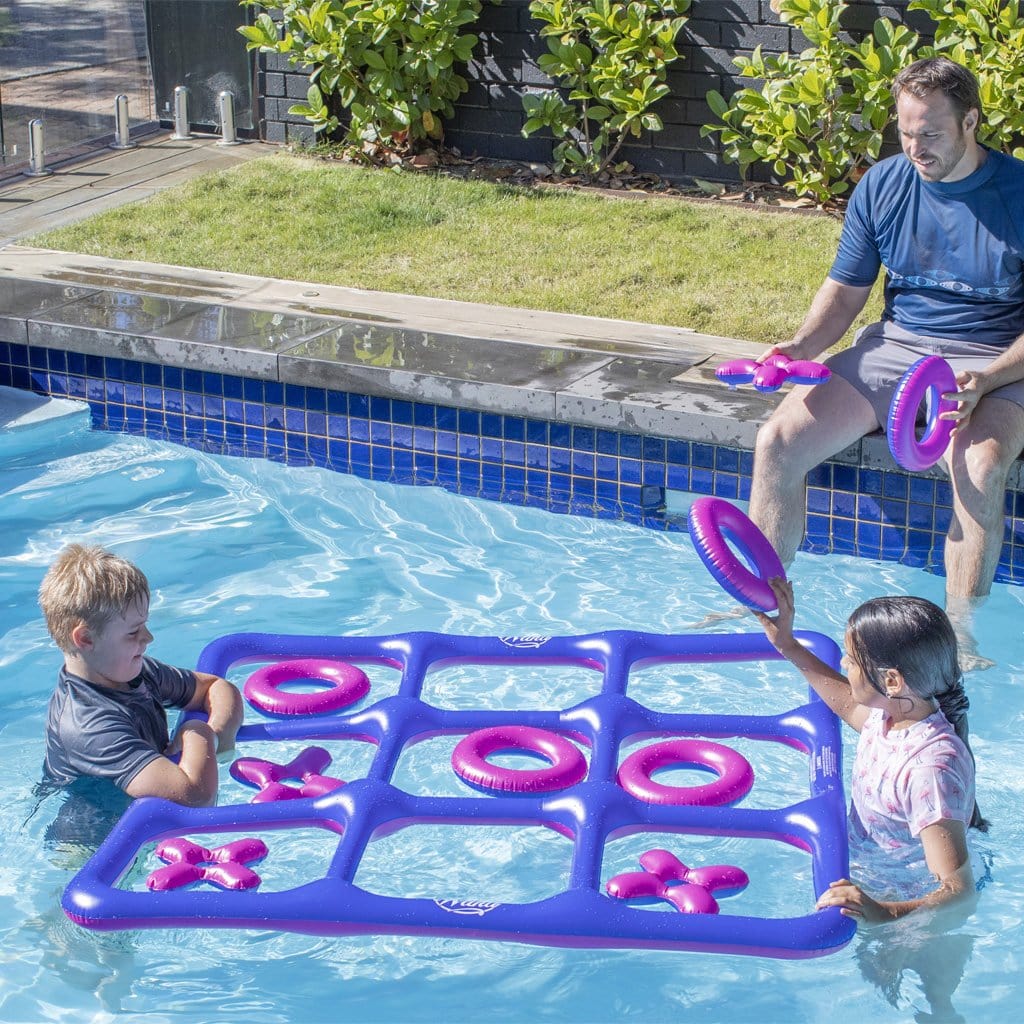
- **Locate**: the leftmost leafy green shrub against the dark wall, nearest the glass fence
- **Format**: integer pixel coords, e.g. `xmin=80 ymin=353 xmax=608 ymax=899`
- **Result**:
xmin=239 ymin=0 xmax=481 ymax=151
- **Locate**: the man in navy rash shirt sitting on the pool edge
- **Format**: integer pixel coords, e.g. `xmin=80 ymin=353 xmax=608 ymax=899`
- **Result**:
xmin=751 ymin=57 xmax=1024 ymax=668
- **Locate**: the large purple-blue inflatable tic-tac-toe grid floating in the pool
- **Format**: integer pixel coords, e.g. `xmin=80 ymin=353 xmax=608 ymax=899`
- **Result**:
xmin=62 ymin=631 xmax=856 ymax=957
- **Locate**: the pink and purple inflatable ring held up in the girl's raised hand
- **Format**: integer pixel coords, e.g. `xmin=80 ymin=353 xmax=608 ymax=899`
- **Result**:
xmin=687 ymin=498 xmax=785 ymax=611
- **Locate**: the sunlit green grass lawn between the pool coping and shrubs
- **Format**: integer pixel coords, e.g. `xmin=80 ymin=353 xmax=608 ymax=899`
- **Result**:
xmin=26 ymin=154 xmax=877 ymax=343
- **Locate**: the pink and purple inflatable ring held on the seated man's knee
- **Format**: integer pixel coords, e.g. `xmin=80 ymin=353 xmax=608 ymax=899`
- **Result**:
xmin=886 ymin=355 xmax=958 ymax=473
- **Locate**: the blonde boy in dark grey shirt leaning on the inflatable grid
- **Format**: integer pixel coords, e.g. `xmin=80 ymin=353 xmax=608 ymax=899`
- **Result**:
xmin=39 ymin=544 xmax=242 ymax=807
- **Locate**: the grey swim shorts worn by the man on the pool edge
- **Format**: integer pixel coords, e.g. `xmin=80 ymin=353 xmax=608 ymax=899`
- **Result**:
xmin=825 ymin=321 xmax=1024 ymax=428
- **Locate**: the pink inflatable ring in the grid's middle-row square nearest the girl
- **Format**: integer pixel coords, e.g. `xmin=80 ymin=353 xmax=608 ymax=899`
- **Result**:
xmin=617 ymin=739 xmax=754 ymax=807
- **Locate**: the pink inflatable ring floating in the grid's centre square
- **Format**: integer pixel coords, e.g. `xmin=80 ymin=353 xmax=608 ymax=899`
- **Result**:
xmin=452 ymin=725 xmax=587 ymax=793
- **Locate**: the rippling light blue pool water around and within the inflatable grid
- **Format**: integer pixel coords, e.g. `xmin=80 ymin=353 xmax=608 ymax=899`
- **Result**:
xmin=0 ymin=403 xmax=1024 ymax=1024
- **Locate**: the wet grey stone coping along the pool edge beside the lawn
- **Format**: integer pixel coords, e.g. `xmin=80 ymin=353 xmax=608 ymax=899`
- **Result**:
xmin=0 ymin=244 xmax=942 ymax=487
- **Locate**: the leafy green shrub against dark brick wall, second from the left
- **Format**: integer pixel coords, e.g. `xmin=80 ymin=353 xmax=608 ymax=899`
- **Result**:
xmin=522 ymin=0 xmax=690 ymax=175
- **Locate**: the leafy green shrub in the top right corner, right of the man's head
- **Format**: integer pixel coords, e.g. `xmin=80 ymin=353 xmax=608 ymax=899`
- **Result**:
xmin=907 ymin=0 xmax=1024 ymax=159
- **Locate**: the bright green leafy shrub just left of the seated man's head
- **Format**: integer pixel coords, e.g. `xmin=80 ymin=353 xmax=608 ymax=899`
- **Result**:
xmin=700 ymin=0 xmax=926 ymax=205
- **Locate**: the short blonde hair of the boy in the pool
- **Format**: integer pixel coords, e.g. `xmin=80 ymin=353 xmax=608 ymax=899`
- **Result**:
xmin=39 ymin=544 xmax=150 ymax=653
